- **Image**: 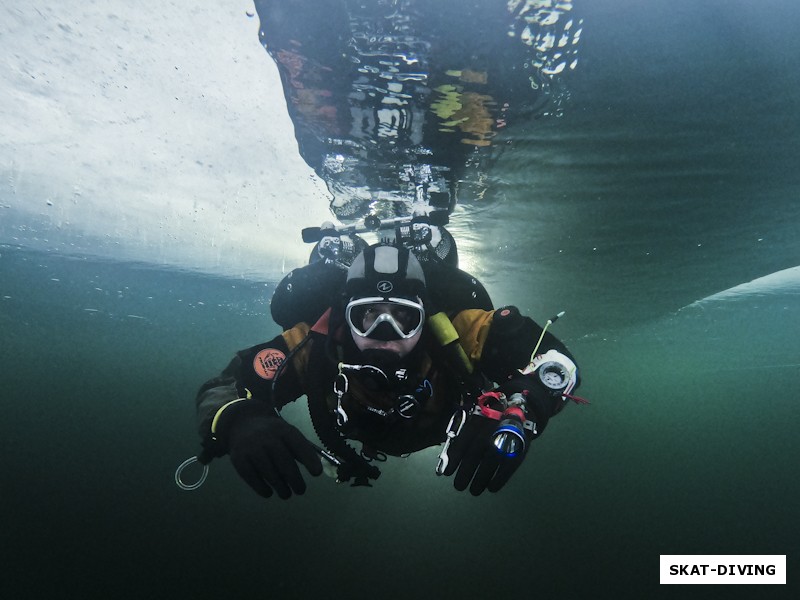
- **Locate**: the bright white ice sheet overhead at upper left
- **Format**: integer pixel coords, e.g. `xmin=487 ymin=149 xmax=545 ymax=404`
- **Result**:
xmin=0 ymin=0 xmax=329 ymax=275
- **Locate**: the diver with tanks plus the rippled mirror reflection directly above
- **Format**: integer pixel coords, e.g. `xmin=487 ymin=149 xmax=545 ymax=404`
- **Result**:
xmin=175 ymin=0 xmax=584 ymax=498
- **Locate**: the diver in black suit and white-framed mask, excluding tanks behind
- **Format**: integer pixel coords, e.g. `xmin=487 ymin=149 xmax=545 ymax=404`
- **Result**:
xmin=196 ymin=243 xmax=582 ymax=499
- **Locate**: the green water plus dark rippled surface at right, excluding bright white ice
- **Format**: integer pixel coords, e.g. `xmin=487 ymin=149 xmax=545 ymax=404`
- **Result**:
xmin=0 ymin=1 xmax=800 ymax=599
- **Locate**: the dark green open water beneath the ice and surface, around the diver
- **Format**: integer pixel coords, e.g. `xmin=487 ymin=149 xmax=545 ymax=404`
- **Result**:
xmin=0 ymin=248 xmax=800 ymax=598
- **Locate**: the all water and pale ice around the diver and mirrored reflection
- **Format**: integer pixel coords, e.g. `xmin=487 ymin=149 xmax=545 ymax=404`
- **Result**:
xmin=0 ymin=0 xmax=800 ymax=598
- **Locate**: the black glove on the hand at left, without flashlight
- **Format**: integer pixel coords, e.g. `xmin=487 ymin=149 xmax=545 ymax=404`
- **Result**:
xmin=218 ymin=400 xmax=322 ymax=500
